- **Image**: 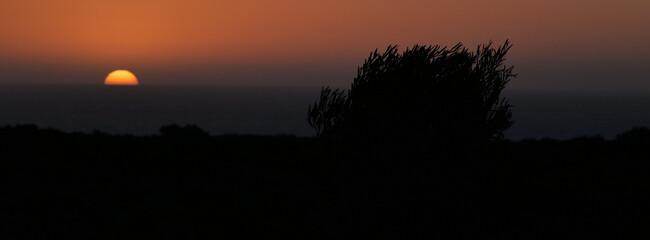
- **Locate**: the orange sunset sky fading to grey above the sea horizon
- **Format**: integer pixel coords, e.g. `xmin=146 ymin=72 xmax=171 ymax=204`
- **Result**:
xmin=0 ymin=0 xmax=650 ymax=92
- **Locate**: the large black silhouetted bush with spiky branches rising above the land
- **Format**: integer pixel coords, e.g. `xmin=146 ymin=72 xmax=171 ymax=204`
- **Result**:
xmin=308 ymin=41 xmax=516 ymax=153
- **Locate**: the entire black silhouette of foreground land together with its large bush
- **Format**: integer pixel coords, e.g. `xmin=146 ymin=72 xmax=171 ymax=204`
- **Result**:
xmin=6 ymin=42 xmax=650 ymax=239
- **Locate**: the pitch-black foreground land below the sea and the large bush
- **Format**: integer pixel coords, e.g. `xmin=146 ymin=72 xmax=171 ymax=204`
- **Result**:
xmin=0 ymin=126 xmax=650 ymax=239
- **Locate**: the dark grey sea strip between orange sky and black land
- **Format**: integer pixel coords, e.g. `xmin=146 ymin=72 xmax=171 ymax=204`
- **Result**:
xmin=0 ymin=85 xmax=650 ymax=140
